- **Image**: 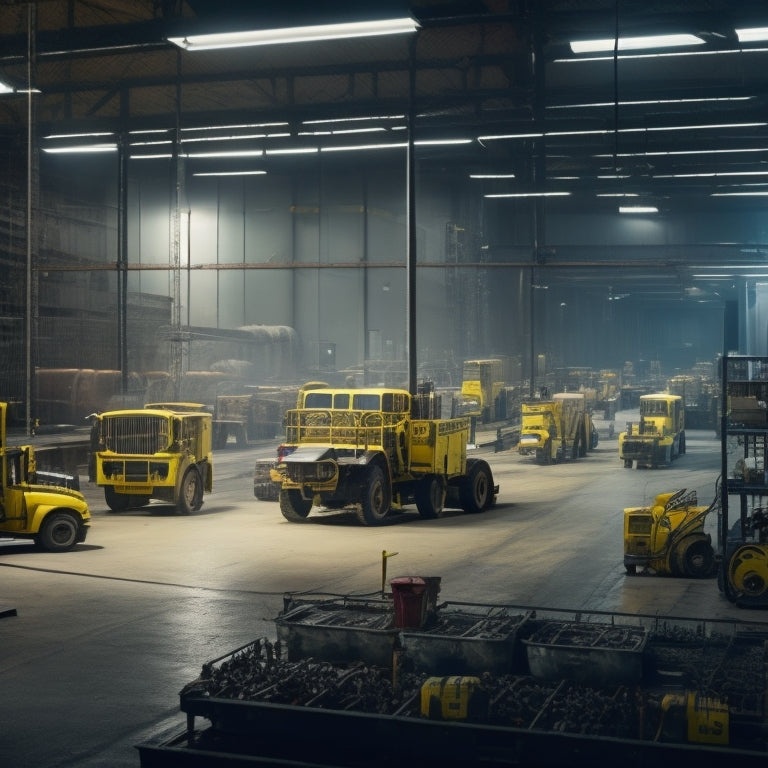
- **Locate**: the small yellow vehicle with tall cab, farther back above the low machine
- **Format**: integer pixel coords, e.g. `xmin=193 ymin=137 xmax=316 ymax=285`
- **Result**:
xmin=619 ymin=393 xmax=685 ymax=469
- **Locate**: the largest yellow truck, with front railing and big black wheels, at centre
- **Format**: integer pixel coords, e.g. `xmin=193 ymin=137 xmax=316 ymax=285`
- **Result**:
xmin=271 ymin=387 xmax=498 ymax=525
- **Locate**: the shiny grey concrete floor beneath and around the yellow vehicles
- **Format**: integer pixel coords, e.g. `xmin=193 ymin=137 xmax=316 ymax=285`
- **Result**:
xmin=0 ymin=414 xmax=768 ymax=768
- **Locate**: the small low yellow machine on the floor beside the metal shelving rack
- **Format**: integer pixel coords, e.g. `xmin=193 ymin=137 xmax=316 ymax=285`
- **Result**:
xmin=624 ymin=488 xmax=719 ymax=578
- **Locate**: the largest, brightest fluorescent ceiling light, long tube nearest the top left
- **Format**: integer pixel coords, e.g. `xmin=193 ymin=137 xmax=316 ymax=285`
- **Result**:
xmin=168 ymin=18 xmax=419 ymax=51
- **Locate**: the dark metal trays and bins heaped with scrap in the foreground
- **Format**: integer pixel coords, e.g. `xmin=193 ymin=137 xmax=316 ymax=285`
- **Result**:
xmin=138 ymin=598 xmax=768 ymax=768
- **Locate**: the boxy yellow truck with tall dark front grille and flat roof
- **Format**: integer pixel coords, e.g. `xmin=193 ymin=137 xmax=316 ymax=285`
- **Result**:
xmin=89 ymin=403 xmax=213 ymax=514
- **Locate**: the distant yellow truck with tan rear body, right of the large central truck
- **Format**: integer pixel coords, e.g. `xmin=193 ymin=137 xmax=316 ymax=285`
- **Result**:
xmin=517 ymin=392 xmax=598 ymax=464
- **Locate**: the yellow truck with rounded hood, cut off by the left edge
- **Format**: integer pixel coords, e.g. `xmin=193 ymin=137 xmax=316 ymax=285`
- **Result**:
xmin=0 ymin=403 xmax=91 ymax=552
